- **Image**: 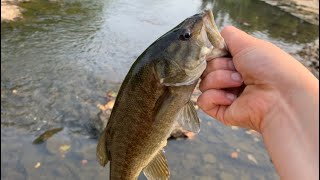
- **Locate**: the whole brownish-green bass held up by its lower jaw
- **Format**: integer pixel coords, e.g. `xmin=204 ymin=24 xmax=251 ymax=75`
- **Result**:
xmin=97 ymin=10 xmax=228 ymax=180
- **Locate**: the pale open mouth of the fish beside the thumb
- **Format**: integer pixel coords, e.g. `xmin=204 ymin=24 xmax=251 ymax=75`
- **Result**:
xmin=201 ymin=10 xmax=229 ymax=60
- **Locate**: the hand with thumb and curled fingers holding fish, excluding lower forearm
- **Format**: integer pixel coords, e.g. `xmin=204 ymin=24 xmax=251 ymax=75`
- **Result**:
xmin=198 ymin=26 xmax=318 ymax=132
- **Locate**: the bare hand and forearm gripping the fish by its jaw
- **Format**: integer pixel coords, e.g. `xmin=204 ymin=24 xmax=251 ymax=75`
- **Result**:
xmin=197 ymin=26 xmax=319 ymax=180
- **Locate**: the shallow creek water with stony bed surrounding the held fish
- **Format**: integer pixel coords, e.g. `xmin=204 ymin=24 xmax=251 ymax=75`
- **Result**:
xmin=1 ymin=0 xmax=319 ymax=179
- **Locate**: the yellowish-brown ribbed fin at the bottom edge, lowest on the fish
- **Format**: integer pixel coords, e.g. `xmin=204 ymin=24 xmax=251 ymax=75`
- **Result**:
xmin=143 ymin=150 xmax=170 ymax=180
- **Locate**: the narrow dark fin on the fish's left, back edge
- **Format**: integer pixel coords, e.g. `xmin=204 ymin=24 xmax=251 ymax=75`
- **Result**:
xmin=96 ymin=129 xmax=109 ymax=166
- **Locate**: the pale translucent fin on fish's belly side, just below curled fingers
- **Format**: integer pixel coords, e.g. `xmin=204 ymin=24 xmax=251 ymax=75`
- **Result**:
xmin=177 ymin=101 xmax=200 ymax=133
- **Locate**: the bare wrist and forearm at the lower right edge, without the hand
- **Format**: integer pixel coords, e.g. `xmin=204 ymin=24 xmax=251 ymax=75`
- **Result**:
xmin=261 ymin=83 xmax=319 ymax=179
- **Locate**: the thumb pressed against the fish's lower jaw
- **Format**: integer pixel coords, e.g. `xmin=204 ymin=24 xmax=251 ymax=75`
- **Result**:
xmin=221 ymin=26 xmax=257 ymax=56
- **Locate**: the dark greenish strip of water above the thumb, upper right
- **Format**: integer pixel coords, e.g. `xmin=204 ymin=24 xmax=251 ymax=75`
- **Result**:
xmin=201 ymin=0 xmax=319 ymax=43
